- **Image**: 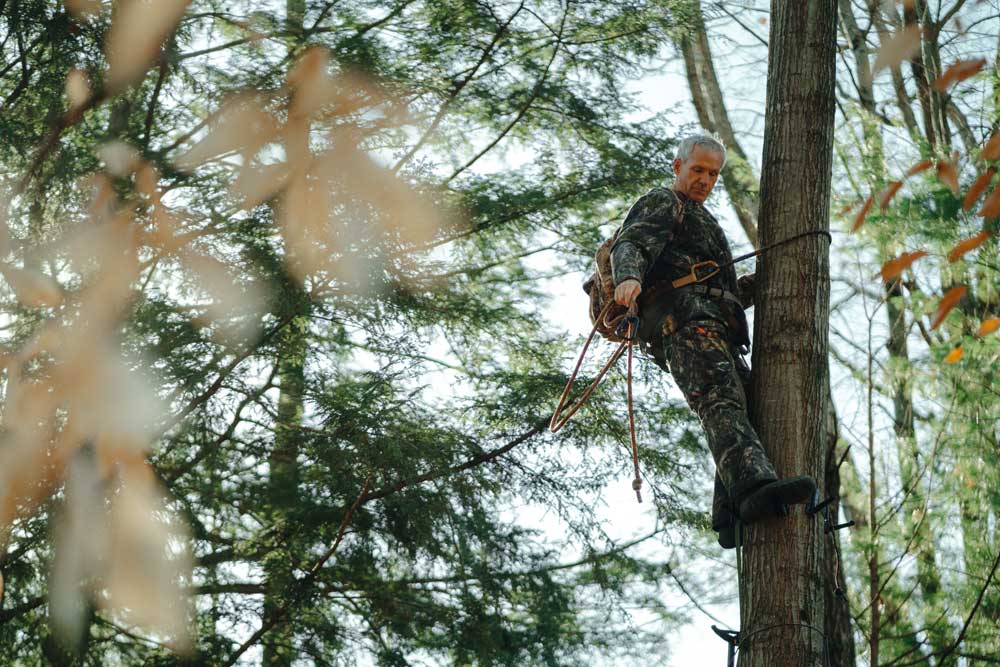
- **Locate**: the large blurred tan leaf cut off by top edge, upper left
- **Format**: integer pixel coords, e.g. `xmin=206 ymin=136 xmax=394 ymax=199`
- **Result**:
xmin=104 ymin=0 xmax=191 ymax=91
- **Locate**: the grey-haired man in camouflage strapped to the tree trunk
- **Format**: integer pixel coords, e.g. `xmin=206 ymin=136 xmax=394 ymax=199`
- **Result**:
xmin=611 ymin=135 xmax=816 ymax=548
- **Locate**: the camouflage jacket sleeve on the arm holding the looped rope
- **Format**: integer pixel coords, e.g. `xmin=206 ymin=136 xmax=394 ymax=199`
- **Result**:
xmin=611 ymin=189 xmax=677 ymax=285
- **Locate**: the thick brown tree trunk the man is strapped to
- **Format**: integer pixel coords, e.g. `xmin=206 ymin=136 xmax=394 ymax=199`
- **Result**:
xmin=740 ymin=0 xmax=837 ymax=667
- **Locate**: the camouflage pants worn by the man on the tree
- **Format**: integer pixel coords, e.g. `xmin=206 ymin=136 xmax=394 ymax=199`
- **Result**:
xmin=663 ymin=320 xmax=778 ymax=527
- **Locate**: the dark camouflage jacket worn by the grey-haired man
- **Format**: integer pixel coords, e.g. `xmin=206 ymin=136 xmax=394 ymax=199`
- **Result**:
xmin=611 ymin=188 xmax=752 ymax=345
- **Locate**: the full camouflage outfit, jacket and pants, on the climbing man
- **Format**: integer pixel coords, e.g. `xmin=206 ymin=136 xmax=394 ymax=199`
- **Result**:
xmin=611 ymin=188 xmax=778 ymax=527
